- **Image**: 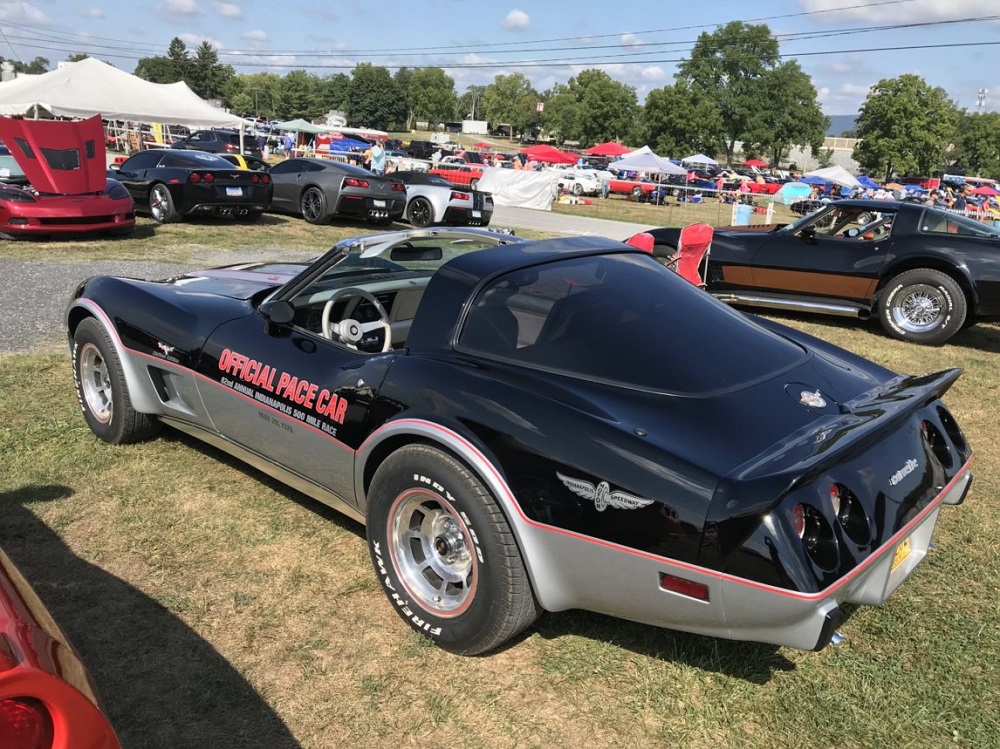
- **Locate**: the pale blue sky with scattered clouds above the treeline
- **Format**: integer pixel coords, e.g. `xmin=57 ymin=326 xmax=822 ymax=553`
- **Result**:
xmin=0 ymin=0 xmax=1000 ymax=114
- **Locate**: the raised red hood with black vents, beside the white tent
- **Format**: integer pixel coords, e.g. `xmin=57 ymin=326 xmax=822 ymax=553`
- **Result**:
xmin=0 ymin=115 xmax=107 ymax=195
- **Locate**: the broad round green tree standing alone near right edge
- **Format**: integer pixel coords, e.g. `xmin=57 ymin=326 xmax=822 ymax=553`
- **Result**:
xmin=853 ymin=73 xmax=958 ymax=180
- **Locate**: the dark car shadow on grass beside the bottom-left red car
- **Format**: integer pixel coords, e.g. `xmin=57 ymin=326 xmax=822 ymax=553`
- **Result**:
xmin=0 ymin=485 xmax=299 ymax=749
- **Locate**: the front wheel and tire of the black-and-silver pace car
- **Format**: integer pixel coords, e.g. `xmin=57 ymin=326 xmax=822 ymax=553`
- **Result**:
xmin=73 ymin=317 xmax=162 ymax=445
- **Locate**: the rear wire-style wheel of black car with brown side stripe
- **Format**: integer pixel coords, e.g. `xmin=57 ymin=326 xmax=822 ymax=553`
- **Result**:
xmin=878 ymin=268 xmax=968 ymax=344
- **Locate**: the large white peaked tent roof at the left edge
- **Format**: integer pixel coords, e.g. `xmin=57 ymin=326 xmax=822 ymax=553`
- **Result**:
xmin=0 ymin=57 xmax=243 ymax=128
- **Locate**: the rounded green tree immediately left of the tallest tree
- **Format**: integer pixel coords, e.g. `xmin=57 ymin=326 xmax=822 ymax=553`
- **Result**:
xmin=637 ymin=81 xmax=725 ymax=159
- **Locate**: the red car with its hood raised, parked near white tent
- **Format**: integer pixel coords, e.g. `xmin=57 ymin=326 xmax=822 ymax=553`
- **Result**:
xmin=0 ymin=115 xmax=135 ymax=239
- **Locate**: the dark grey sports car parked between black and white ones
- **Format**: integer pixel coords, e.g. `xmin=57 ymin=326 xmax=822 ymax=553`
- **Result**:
xmin=271 ymin=158 xmax=406 ymax=226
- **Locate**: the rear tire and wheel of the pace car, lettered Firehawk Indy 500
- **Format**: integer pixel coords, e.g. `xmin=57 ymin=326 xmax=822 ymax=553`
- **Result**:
xmin=367 ymin=445 xmax=540 ymax=655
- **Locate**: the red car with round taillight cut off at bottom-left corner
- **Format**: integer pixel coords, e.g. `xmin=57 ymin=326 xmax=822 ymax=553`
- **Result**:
xmin=0 ymin=551 xmax=120 ymax=749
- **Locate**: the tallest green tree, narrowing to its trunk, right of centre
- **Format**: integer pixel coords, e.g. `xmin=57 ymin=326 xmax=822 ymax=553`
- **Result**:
xmin=677 ymin=21 xmax=780 ymax=161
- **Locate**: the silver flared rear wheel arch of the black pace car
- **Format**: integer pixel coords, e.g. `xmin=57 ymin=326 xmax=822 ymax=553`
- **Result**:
xmin=355 ymin=418 xmax=567 ymax=611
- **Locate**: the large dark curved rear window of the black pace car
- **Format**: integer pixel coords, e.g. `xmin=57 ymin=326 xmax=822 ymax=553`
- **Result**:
xmin=458 ymin=253 xmax=806 ymax=394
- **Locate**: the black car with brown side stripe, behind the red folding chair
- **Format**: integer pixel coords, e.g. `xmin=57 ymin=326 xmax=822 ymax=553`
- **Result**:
xmin=650 ymin=200 xmax=1000 ymax=344
